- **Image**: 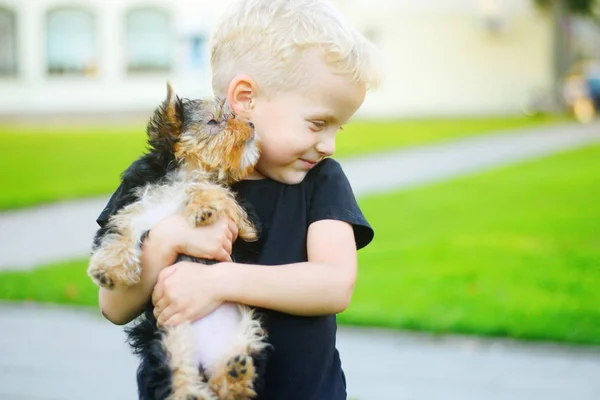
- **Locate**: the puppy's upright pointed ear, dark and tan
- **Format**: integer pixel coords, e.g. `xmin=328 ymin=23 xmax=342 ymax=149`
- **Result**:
xmin=148 ymin=82 xmax=183 ymax=149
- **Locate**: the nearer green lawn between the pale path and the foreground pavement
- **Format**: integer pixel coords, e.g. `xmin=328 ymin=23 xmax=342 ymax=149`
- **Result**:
xmin=0 ymin=141 xmax=600 ymax=344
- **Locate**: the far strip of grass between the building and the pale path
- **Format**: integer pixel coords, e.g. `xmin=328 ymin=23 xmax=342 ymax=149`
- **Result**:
xmin=0 ymin=117 xmax=565 ymax=210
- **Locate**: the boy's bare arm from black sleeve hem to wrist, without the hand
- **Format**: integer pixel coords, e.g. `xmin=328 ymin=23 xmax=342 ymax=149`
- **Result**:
xmin=221 ymin=220 xmax=358 ymax=316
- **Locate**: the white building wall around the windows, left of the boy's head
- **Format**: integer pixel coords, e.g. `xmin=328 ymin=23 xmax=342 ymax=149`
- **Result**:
xmin=0 ymin=0 xmax=234 ymax=115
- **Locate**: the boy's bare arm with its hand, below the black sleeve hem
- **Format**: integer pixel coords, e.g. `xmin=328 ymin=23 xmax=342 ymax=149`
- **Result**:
xmin=152 ymin=220 xmax=357 ymax=325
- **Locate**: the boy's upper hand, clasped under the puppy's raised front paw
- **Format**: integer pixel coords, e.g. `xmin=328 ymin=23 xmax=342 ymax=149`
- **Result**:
xmin=151 ymin=214 xmax=238 ymax=261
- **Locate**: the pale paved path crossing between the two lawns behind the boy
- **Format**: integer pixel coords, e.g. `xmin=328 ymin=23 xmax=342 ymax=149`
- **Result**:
xmin=0 ymin=123 xmax=600 ymax=269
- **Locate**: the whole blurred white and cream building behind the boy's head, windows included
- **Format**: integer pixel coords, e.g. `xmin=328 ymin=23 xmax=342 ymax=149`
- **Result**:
xmin=0 ymin=0 xmax=600 ymax=117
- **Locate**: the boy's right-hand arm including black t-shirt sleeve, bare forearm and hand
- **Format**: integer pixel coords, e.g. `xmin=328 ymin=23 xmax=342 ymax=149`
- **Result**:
xmin=152 ymin=159 xmax=374 ymax=325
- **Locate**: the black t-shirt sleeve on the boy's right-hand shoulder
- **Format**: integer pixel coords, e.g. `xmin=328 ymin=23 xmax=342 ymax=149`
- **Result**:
xmin=308 ymin=158 xmax=374 ymax=249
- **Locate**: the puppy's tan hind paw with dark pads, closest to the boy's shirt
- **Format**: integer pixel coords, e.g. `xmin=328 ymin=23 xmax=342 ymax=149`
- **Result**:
xmin=209 ymin=354 xmax=256 ymax=400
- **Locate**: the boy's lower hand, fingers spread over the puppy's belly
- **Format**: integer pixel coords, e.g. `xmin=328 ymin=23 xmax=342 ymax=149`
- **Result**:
xmin=152 ymin=261 xmax=223 ymax=326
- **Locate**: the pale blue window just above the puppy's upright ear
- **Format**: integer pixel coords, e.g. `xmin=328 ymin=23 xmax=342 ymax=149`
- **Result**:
xmin=125 ymin=8 xmax=173 ymax=72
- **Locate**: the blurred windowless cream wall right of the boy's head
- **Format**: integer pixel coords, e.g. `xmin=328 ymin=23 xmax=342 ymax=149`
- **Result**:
xmin=340 ymin=0 xmax=552 ymax=117
